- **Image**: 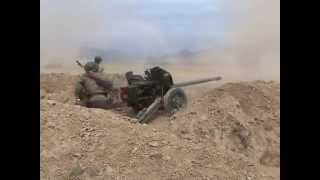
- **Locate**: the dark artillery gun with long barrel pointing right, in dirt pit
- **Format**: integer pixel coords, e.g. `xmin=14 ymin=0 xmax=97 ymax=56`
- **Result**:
xmin=120 ymin=66 xmax=221 ymax=123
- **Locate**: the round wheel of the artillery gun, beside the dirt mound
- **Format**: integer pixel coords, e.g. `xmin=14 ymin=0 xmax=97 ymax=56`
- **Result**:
xmin=164 ymin=88 xmax=188 ymax=114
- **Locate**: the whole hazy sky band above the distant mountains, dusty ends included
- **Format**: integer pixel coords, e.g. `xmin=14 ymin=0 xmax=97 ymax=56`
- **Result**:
xmin=40 ymin=0 xmax=280 ymax=64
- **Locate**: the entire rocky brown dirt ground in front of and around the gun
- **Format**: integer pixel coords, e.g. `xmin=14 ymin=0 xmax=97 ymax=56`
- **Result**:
xmin=40 ymin=75 xmax=280 ymax=179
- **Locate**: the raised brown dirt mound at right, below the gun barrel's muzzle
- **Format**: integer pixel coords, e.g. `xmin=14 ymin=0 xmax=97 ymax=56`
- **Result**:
xmin=173 ymin=81 xmax=280 ymax=167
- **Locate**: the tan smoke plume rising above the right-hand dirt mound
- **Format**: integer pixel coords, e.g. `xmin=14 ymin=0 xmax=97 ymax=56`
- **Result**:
xmin=228 ymin=0 xmax=280 ymax=80
